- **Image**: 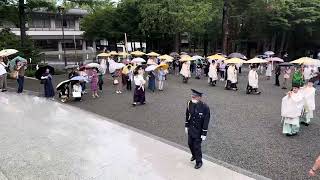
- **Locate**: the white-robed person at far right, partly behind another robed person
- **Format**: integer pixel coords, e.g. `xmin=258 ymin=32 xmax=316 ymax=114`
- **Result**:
xmin=301 ymin=81 xmax=316 ymax=126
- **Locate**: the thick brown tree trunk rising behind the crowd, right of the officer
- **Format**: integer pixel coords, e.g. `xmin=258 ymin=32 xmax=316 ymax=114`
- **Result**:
xmin=222 ymin=0 xmax=229 ymax=54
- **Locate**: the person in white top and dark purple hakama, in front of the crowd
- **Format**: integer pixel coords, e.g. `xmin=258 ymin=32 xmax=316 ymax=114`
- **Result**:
xmin=132 ymin=66 xmax=146 ymax=106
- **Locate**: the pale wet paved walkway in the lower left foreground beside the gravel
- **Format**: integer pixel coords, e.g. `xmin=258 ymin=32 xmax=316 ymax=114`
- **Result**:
xmin=0 ymin=93 xmax=252 ymax=180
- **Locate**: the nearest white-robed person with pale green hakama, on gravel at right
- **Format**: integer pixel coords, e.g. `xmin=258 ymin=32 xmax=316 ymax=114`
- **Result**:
xmin=281 ymin=84 xmax=304 ymax=136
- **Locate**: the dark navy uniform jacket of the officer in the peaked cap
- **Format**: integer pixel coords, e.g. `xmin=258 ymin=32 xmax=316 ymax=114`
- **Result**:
xmin=185 ymin=101 xmax=210 ymax=138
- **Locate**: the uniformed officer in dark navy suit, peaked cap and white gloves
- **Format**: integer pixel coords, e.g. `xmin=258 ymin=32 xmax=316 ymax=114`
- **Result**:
xmin=185 ymin=89 xmax=210 ymax=169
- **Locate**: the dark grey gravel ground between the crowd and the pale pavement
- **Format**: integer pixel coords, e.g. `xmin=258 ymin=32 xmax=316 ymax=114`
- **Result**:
xmin=6 ymin=68 xmax=320 ymax=180
